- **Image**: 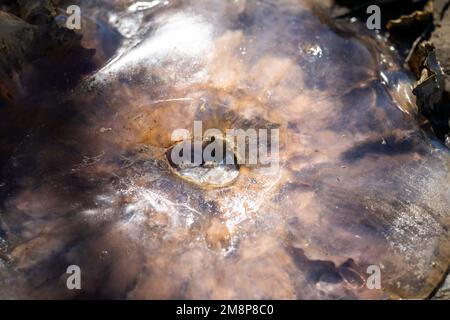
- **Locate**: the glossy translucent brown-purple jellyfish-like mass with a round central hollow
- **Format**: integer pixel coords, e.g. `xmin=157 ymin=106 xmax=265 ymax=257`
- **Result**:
xmin=0 ymin=0 xmax=450 ymax=299
